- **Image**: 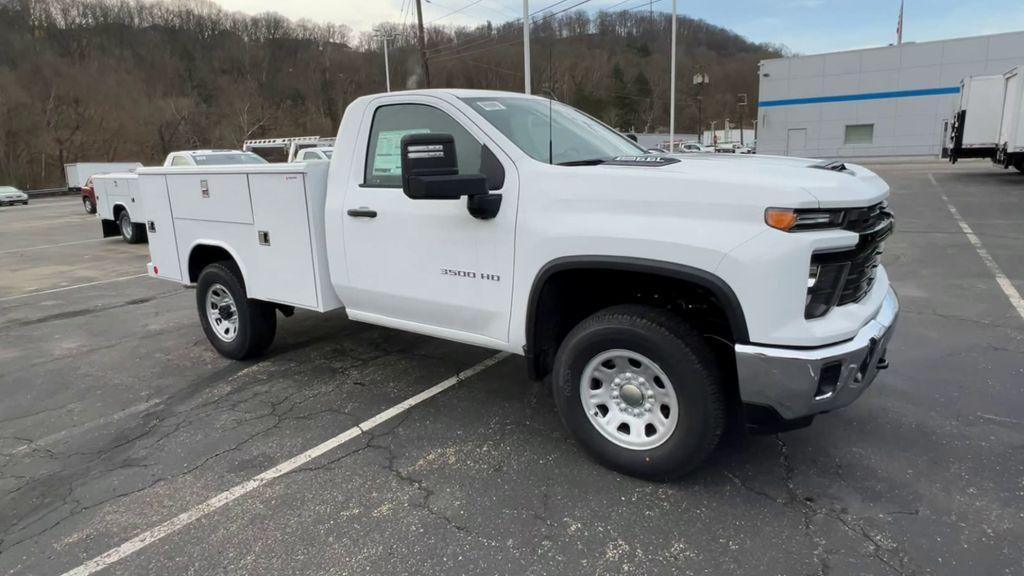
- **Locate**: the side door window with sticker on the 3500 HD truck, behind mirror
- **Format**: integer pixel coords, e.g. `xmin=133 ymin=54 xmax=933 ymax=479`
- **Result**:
xmin=362 ymin=104 xmax=483 ymax=188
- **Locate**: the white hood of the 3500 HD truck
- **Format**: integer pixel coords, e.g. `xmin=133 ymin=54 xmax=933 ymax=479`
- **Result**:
xmin=601 ymin=154 xmax=889 ymax=208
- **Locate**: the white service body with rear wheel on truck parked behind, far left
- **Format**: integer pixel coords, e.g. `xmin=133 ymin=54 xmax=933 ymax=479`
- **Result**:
xmin=92 ymin=172 xmax=145 ymax=244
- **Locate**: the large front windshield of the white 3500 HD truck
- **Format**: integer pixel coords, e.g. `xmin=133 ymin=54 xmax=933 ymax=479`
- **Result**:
xmin=462 ymin=96 xmax=647 ymax=164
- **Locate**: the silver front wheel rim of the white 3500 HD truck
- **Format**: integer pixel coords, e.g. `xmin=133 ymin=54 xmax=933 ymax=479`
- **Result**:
xmin=580 ymin=349 xmax=679 ymax=450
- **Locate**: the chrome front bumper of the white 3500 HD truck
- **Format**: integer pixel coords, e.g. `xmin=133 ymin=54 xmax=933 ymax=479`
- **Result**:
xmin=735 ymin=288 xmax=899 ymax=420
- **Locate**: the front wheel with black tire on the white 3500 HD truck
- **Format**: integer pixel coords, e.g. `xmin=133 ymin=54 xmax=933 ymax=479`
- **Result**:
xmin=552 ymin=304 xmax=726 ymax=480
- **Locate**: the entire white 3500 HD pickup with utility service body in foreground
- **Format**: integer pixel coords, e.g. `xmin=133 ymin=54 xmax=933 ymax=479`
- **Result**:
xmin=139 ymin=90 xmax=898 ymax=478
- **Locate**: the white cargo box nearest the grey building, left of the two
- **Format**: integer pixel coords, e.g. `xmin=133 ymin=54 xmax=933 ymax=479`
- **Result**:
xmin=949 ymin=74 xmax=1004 ymax=164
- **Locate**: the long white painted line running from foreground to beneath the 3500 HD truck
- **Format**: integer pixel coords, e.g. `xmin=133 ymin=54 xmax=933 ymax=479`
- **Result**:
xmin=63 ymin=352 xmax=508 ymax=576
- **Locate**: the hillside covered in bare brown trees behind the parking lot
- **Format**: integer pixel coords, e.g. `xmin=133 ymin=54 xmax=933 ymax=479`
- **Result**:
xmin=0 ymin=0 xmax=780 ymax=188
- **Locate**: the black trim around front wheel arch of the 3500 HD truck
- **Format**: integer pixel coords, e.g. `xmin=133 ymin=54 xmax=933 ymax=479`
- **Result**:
xmin=523 ymin=255 xmax=750 ymax=379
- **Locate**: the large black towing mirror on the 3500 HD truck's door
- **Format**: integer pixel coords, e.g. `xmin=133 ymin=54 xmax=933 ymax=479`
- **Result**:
xmin=401 ymin=133 xmax=504 ymax=220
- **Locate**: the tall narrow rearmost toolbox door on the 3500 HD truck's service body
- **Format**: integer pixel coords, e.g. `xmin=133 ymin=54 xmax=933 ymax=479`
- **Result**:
xmin=138 ymin=174 xmax=182 ymax=282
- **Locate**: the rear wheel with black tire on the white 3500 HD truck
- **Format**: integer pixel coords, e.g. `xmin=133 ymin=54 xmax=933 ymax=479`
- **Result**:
xmin=196 ymin=261 xmax=278 ymax=360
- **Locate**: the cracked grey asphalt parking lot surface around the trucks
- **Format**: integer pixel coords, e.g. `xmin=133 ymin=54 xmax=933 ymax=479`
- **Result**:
xmin=0 ymin=162 xmax=1024 ymax=576
